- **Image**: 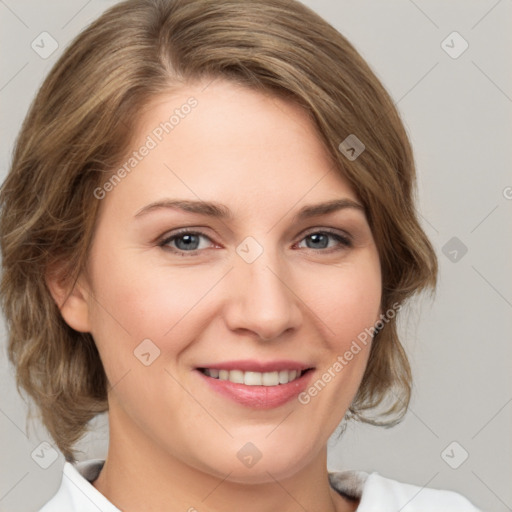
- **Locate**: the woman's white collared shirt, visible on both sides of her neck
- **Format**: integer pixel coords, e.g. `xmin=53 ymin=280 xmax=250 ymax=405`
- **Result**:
xmin=39 ymin=459 xmax=481 ymax=512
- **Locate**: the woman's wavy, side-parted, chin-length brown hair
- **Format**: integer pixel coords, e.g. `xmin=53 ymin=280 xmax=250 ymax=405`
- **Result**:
xmin=0 ymin=0 xmax=437 ymax=461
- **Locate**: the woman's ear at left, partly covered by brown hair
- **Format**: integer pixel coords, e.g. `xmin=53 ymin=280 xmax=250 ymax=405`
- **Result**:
xmin=45 ymin=267 xmax=90 ymax=332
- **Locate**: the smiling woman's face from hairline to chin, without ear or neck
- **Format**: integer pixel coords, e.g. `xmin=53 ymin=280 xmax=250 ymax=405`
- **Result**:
xmin=77 ymin=81 xmax=381 ymax=482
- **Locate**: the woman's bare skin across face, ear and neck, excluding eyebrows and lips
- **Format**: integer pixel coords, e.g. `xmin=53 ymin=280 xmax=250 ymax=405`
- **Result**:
xmin=49 ymin=80 xmax=382 ymax=512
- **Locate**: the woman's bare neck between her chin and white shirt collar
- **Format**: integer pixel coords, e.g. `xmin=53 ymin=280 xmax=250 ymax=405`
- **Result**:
xmin=93 ymin=411 xmax=357 ymax=512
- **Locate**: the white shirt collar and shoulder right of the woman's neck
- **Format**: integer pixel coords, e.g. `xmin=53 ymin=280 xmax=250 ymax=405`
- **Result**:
xmin=329 ymin=471 xmax=481 ymax=512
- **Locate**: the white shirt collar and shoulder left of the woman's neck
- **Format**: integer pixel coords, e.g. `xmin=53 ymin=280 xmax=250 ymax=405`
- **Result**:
xmin=39 ymin=460 xmax=120 ymax=512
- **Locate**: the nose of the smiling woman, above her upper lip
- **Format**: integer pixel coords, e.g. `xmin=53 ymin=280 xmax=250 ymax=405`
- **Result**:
xmin=226 ymin=250 xmax=302 ymax=341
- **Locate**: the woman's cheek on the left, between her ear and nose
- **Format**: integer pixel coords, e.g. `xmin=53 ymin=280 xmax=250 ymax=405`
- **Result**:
xmin=87 ymin=248 xmax=225 ymax=357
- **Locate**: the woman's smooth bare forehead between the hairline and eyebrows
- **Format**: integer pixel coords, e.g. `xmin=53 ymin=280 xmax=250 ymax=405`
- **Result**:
xmin=100 ymin=81 xmax=356 ymax=218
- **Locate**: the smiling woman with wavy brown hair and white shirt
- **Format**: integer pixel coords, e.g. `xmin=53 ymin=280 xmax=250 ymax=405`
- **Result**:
xmin=0 ymin=0 xmax=476 ymax=512
